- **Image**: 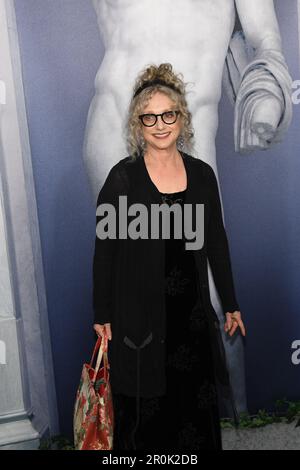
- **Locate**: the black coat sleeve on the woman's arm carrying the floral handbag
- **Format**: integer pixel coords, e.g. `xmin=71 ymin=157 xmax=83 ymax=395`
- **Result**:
xmin=93 ymin=165 xmax=125 ymax=324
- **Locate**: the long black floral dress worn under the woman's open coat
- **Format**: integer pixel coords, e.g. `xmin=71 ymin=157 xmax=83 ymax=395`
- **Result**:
xmin=113 ymin=191 xmax=222 ymax=452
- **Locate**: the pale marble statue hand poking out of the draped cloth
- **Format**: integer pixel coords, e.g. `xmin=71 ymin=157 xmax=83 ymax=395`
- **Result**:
xmin=251 ymin=96 xmax=282 ymax=142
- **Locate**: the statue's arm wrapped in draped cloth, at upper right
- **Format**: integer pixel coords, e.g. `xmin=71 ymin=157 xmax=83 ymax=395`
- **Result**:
xmin=235 ymin=0 xmax=292 ymax=151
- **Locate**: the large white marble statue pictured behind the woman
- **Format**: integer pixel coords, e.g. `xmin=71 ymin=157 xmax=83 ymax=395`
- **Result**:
xmin=83 ymin=0 xmax=292 ymax=411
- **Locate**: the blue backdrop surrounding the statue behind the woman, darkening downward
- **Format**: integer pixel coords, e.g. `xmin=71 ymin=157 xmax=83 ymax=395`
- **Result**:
xmin=15 ymin=0 xmax=300 ymax=435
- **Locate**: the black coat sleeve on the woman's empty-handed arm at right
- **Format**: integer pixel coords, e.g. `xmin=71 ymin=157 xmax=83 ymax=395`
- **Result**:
xmin=207 ymin=165 xmax=240 ymax=315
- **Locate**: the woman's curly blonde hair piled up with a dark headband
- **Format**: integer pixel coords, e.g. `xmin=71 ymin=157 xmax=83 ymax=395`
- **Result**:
xmin=126 ymin=63 xmax=194 ymax=160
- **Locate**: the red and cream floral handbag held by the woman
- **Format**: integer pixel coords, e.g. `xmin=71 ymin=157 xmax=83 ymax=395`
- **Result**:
xmin=73 ymin=334 xmax=114 ymax=450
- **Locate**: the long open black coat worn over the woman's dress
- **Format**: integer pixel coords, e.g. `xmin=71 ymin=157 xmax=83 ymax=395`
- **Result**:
xmin=93 ymin=152 xmax=239 ymax=424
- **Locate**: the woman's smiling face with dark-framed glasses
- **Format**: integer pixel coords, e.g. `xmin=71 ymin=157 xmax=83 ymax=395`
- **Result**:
xmin=141 ymin=91 xmax=182 ymax=155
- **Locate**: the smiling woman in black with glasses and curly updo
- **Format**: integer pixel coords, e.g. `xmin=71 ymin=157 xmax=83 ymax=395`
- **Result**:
xmin=93 ymin=64 xmax=245 ymax=452
